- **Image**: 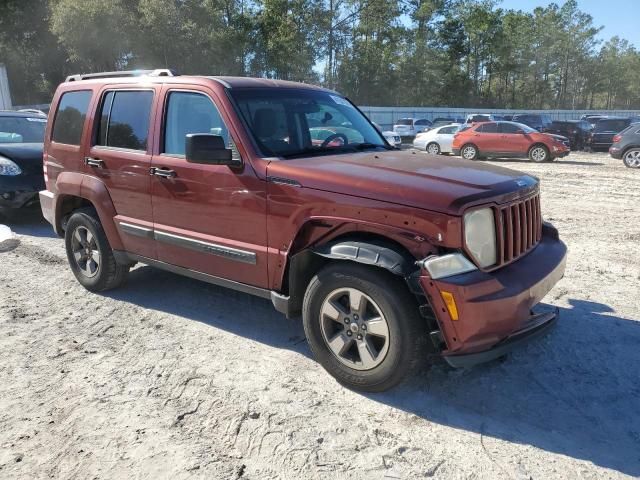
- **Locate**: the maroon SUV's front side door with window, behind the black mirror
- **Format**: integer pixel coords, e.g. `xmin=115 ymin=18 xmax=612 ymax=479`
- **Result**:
xmin=152 ymin=86 xmax=268 ymax=288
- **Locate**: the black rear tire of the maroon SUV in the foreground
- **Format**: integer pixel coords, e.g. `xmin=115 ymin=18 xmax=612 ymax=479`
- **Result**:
xmin=64 ymin=208 xmax=130 ymax=292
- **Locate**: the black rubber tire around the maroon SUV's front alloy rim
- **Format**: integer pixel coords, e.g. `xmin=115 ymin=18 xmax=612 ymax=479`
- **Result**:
xmin=302 ymin=261 xmax=428 ymax=392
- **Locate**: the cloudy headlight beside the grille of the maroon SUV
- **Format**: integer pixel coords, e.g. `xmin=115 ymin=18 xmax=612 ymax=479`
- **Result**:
xmin=464 ymin=208 xmax=497 ymax=268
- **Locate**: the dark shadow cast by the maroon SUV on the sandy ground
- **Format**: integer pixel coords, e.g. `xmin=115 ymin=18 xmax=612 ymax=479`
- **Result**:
xmin=109 ymin=267 xmax=640 ymax=476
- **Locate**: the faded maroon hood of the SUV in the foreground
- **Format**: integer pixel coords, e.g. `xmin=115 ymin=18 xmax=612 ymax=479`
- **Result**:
xmin=268 ymin=150 xmax=538 ymax=215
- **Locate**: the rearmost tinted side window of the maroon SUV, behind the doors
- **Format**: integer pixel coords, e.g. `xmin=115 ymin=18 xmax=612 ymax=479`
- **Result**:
xmin=51 ymin=90 xmax=92 ymax=145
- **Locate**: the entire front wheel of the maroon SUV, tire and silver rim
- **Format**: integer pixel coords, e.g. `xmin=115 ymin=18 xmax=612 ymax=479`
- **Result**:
xmin=303 ymin=262 xmax=427 ymax=392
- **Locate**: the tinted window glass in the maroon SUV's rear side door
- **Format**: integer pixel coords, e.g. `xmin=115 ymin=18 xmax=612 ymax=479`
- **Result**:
xmin=96 ymin=91 xmax=153 ymax=151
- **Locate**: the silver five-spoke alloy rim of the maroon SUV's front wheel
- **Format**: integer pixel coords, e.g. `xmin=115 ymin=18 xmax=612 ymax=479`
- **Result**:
xmin=320 ymin=288 xmax=389 ymax=370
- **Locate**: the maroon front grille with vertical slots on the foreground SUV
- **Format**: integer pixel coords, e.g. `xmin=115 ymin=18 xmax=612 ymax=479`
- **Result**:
xmin=496 ymin=194 xmax=542 ymax=266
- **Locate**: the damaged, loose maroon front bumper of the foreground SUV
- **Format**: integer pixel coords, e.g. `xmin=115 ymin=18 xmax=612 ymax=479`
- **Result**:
xmin=420 ymin=224 xmax=567 ymax=365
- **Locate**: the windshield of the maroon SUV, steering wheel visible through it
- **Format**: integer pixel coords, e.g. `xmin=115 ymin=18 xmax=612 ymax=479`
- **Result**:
xmin=230 ymin=88 xmax=391 ymax=158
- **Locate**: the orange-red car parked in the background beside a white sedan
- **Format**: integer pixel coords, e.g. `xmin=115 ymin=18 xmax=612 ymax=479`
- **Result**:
xmin=453 ymin=122 xmax=571 ymax=162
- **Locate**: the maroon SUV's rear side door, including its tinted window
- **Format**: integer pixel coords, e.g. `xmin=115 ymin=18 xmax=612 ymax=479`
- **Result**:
xmin=85 ymin=86 xmax=160 ymax=258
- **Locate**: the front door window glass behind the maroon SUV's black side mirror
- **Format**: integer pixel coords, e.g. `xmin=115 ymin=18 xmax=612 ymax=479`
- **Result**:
xmin=163 ymin=92 xmax=233 ymax=155
